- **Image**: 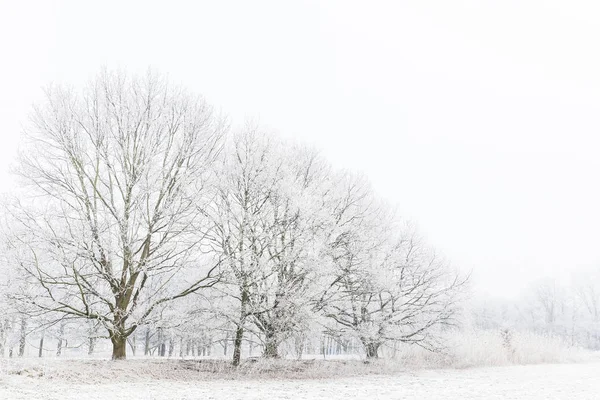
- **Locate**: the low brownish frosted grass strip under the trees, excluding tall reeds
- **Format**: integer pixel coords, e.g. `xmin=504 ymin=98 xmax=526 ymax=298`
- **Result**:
xmin=0 ymin=359 xmax=406 ymax=384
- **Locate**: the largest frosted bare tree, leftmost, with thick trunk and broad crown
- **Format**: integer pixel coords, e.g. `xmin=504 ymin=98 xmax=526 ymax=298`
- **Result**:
xmin=11 ymin=71 xmax=225 ymax=359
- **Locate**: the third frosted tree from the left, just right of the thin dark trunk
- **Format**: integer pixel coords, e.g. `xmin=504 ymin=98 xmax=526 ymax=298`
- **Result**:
xmin=248 ymin=142 xmax=330 ymax=357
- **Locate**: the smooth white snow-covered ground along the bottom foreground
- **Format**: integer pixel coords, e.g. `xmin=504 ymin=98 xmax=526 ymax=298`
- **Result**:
xmin=0 ymin=362 xmax=600 ymax=400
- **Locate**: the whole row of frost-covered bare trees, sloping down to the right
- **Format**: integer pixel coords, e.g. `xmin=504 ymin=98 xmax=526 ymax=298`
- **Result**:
xmin=0 ymin=71 xmax=466 ymax=364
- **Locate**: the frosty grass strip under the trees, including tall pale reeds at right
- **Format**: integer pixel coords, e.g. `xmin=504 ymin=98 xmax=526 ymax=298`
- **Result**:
xmin=0 ymin=330 xmax=600 ymax=384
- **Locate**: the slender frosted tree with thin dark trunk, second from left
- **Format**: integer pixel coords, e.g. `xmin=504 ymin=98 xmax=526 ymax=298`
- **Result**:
xmin=204 ymin=131 xmax=280 ymax=365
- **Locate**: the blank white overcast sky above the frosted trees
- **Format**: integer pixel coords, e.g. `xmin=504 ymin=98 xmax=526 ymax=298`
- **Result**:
xmin=0 ymin=0 xmax=600 ymax=296
